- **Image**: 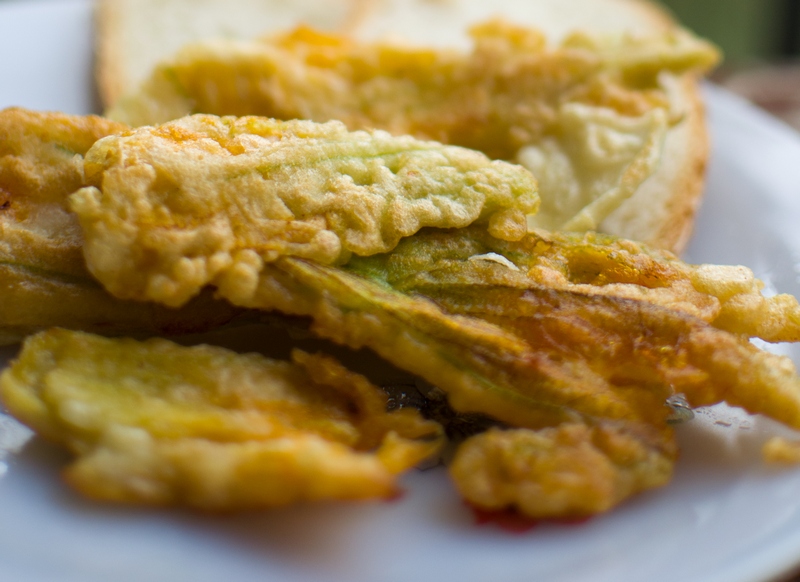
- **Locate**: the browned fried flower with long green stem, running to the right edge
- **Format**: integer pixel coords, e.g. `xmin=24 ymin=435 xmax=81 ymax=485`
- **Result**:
xmin=245 ymin=253 xmax=800 ymax=427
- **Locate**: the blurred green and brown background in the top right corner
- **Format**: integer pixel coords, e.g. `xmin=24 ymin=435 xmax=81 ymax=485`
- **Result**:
xmin=660 ymin=0 xmax=800 ymax=129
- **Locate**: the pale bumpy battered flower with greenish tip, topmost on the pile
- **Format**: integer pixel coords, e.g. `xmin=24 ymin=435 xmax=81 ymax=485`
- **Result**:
xmin=71 ymin=115 xmax=539 ymax=306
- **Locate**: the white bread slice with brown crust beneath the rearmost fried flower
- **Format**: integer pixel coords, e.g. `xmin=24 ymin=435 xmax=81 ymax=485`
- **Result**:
xmin=97 ymin=0 xmax=708 ymax=252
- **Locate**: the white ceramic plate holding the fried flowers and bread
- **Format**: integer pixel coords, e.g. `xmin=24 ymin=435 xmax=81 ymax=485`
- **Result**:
xmin=0 ymin=0 xmax=800 ymax=582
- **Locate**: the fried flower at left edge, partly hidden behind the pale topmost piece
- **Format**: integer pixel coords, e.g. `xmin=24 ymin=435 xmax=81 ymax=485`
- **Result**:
xmin=0 ymin=108 xmax=241 ymax=344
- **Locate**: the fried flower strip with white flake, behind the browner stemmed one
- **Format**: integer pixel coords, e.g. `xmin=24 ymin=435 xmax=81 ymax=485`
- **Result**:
xmin=349 ymin=229 xmax=800 ymax=342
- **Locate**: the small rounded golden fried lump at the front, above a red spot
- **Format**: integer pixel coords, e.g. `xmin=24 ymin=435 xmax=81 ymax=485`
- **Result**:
xmin=450 ymin=424 xmax=673 ymax=518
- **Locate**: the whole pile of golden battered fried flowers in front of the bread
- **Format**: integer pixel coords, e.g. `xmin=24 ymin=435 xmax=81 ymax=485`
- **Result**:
xmin=0 ymin=20 xmax=800 ymax=518
